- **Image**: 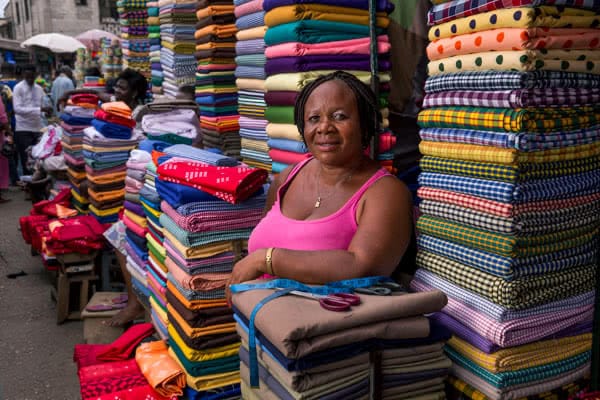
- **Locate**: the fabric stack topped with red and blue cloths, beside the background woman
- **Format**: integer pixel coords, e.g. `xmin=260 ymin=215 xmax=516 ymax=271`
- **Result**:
xmin=83 ymin=102 xmax=140 ymax=222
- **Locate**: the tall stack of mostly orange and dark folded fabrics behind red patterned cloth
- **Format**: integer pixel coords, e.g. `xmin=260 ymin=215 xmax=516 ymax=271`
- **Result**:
xmin=194 ymin=0 xmax=240 ymax=158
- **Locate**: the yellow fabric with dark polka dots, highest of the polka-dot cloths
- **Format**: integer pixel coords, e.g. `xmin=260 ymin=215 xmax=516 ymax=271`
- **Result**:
xmin=429 ymin=6 xmax=600 ymax=41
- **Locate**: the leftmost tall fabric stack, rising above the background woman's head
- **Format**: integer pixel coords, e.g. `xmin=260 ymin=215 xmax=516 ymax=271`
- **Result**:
xmin=117 ymin=0 xmax=151 ymax=79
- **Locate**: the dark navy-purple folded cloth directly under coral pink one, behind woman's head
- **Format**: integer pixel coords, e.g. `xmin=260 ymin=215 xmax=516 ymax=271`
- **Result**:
xmin=265 ymin=54 xmax=391 ymax=76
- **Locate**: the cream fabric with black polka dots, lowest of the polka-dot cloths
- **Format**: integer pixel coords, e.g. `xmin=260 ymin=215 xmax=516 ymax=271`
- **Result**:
xmin=427 ymin=50 xmax=600 ymax=76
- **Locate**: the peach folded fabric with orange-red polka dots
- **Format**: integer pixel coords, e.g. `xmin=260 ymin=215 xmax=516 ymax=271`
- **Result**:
xmin=427 ymin=28 xmax=600 ymax=60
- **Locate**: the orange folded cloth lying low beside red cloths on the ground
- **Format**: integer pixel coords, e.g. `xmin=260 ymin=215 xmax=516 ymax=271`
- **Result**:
xmin=135 ymin=340 xmax=187 ymax=397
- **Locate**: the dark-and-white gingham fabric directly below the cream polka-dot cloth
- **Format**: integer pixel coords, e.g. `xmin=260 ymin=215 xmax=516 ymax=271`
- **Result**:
xmin=425 ymin=71 xmax=600 ymax=93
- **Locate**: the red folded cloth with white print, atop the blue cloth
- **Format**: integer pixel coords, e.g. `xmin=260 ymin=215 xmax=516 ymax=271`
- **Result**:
xmin=158 ymin=159 xmax=267 ymax=204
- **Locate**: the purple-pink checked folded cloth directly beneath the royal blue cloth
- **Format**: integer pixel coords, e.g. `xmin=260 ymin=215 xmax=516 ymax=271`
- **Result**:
xmin=160 ymin=201 xmax=263 ymax=232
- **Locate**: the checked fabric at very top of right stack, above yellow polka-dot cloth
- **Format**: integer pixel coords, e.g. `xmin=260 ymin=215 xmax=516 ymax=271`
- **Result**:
xmin=427 ymin=0 xmax=540 ymax=25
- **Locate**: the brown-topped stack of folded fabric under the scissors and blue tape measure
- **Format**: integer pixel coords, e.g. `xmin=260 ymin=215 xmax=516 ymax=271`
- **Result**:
xmin=233 ymin=281 xmax=451 ymax=400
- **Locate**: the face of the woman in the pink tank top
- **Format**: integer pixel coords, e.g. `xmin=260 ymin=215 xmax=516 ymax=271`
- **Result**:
xmin=304 ymin=79 xmax=362 ymax=165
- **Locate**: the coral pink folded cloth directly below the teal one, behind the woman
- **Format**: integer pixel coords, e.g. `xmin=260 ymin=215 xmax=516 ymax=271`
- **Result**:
xmin=265 ymin=35 xmax=391 ymax=58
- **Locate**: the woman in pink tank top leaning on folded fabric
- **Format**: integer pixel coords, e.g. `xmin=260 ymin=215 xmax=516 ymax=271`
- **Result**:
xmin=229 ymin=71 xmax=412 ymax=300
